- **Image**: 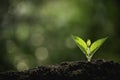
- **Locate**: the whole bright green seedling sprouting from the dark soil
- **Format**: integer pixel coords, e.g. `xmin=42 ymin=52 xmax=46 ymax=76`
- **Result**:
xmin=72 ymin=35 xmax=107 ymax=62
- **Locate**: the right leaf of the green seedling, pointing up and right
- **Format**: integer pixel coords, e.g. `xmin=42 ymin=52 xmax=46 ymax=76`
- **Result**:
xmin=90 ymin=37 xmax=108 ymax=55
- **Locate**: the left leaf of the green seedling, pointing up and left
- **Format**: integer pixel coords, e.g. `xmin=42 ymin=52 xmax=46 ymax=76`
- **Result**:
xmin=72 ymin=35 xmax=87 ymax=55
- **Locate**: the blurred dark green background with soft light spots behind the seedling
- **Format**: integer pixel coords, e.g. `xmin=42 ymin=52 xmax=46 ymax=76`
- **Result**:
xmin=0 ymin=0 xmax=120 ymax=71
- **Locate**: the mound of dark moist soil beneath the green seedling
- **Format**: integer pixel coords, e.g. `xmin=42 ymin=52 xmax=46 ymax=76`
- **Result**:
xmin=0 ymin=60 xmax=120 ymax=80
